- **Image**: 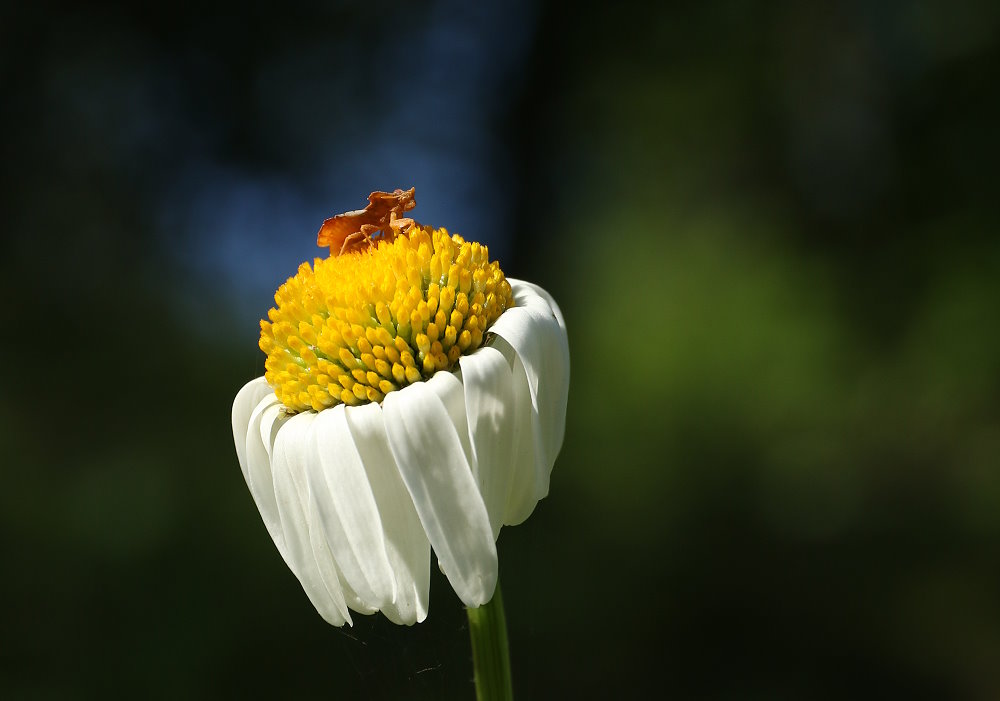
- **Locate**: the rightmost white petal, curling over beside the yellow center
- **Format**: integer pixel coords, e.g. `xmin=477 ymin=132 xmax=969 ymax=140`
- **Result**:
xmin=490 ymin=280 xmax=569 ymax=498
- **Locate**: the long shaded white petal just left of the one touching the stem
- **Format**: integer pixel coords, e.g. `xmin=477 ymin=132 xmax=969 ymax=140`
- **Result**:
xmin=345 ymin=403 xmax=431 ymax=625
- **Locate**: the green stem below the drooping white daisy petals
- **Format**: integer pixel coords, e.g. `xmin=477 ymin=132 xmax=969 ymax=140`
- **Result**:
xmin=467 ymin=583 xmax=514 ymax=701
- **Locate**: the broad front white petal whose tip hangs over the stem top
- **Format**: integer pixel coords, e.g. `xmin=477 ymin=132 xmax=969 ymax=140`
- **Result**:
xmin=383 ymin=373 xmax=497 ymax=606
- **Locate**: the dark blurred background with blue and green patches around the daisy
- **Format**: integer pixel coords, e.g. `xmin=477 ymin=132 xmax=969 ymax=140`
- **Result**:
xmin=0 ymin=0 xmax=1000 ymax=699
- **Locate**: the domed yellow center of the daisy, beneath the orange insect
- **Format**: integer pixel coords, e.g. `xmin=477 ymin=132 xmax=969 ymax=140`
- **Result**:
xmin=260 ymin=226 xmax=514 ymax=412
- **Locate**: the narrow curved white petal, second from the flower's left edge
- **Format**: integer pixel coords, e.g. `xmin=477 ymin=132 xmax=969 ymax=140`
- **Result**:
xmin=243 ymin=392 xmax=288 ymax=562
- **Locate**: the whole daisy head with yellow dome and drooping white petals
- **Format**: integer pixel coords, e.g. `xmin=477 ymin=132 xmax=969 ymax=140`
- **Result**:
xmin=233 ymin=191 xmax=569 ymax=625
